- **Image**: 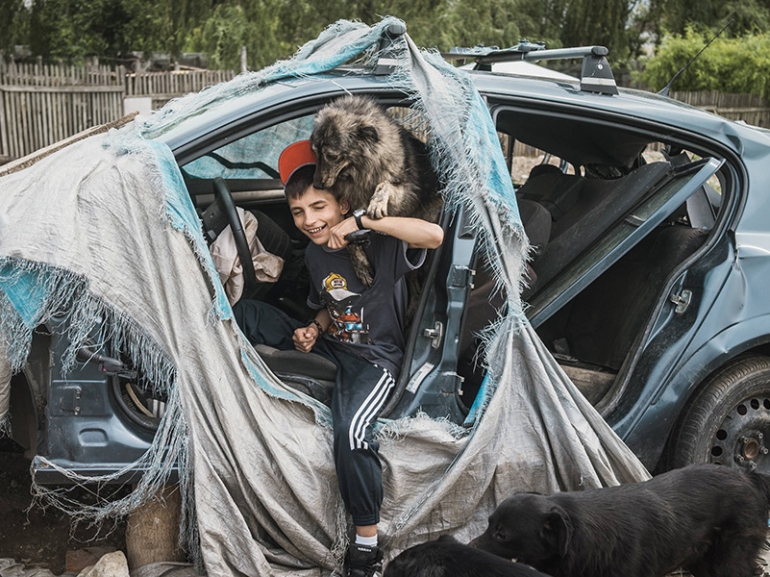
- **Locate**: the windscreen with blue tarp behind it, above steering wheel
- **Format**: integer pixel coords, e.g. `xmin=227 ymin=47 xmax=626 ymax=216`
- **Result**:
xmin=182 ymin=114 xmax=315 ymax=179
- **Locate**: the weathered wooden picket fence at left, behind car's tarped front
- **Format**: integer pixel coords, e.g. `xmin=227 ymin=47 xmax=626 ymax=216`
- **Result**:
xmin=0 ymin=58 xmax=235 ymax=162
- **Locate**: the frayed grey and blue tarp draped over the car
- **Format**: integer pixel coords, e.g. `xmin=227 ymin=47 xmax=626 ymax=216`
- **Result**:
xmin=0 ymin=18 xmax=647 ymax=576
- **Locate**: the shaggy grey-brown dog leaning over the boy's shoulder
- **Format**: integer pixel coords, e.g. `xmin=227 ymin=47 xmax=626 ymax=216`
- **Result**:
xmin=310 ymin=96 xmax=441 ymax=286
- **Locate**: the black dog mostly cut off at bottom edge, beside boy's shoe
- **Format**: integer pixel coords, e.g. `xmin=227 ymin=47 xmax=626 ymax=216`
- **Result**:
xmin=383 ymin=536 xmax=548 ymax=577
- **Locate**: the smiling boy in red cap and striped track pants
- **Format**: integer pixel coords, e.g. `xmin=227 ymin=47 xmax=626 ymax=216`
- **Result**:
xmin=233 ymin=140 xmax=444 ymax=577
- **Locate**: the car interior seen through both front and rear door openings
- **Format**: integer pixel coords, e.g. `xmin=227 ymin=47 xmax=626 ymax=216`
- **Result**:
xmin=123 ymin=98 xmax=728 ymax=423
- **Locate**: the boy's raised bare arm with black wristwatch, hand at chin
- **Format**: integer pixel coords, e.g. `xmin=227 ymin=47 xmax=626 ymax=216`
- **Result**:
xmin=328 ymin=215 xmax=444 ymax=249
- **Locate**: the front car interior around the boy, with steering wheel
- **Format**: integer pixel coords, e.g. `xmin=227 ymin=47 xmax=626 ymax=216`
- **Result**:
xmin=181 ymin=107 xmax=469 ymax=412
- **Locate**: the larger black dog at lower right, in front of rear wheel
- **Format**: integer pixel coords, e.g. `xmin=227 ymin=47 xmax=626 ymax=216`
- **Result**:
xmin=471 ymin=465 xmax=770 ymax=577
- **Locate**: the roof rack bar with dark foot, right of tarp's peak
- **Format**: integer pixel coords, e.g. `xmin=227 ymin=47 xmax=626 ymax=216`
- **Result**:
xmin=441 ymin=40 xmax=618 ymax=95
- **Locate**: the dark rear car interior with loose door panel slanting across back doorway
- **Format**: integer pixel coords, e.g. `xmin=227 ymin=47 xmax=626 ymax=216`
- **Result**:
xmin=461 ymin=109 xmax=727 ymax=405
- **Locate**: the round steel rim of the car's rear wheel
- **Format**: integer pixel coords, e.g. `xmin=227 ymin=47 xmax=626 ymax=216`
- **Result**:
xmin=709 ymin=393 xmax=770 ymax=473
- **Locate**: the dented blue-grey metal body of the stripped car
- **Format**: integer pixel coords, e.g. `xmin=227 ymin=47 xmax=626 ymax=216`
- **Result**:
xmin=12 ymin=62 xmax=770 ymax=482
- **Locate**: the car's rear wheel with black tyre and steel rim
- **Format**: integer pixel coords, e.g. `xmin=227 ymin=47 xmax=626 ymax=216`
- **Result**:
xmin=668 ymin=356 xmax=770 ymax=473
